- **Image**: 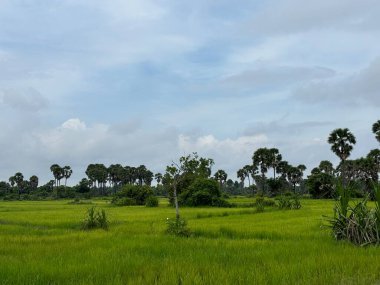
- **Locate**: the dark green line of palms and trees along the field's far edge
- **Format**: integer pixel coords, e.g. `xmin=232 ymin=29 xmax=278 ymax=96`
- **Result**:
xmin=0 ymin=120 xmax=380 ymax=200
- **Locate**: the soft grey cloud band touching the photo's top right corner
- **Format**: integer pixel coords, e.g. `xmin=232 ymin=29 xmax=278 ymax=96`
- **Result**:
xmin=251 ymin=0 xmax=380 ymax=35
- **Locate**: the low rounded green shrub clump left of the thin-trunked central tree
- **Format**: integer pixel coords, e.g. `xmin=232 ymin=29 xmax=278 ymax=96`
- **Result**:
xmin=112 ymin=184 xmax=153 ymax=206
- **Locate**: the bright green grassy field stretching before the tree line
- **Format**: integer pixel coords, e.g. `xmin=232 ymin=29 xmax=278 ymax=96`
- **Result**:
xmin=0 ymin=198 xmax=380 ymax=284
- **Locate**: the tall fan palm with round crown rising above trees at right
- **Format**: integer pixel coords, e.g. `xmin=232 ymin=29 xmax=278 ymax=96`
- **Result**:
xmin=327 ymin=128 xmax=356 ymax=184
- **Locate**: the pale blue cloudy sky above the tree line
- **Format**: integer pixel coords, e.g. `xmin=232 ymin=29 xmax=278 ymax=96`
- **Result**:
xmin=0 ymin=0 xmax=380 ymax=184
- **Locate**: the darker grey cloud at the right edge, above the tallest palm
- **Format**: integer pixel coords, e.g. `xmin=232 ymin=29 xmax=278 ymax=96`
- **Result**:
xmin=293 ymin=59 xmax=380 ymax=107
